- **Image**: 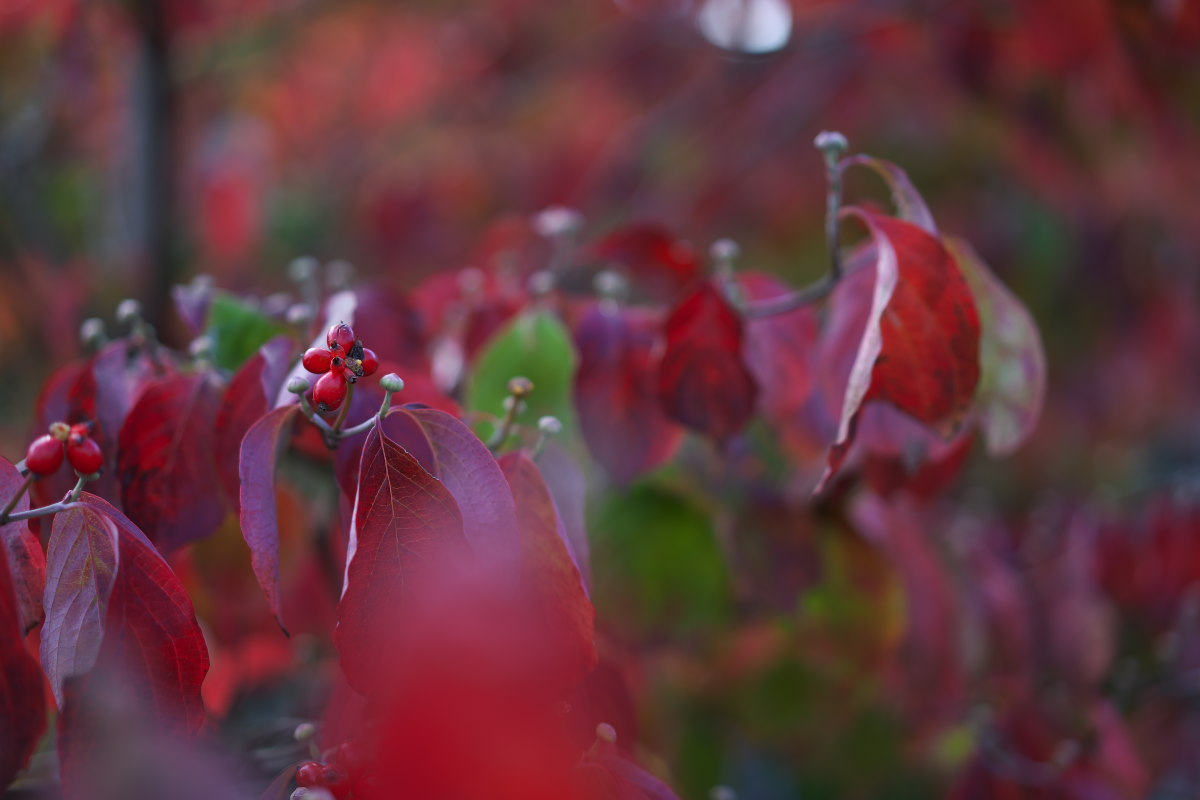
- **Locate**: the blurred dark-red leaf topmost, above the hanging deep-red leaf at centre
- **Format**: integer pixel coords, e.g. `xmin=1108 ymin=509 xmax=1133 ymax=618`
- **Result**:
xmin=590 ymin=222 xmax=701 ymax=302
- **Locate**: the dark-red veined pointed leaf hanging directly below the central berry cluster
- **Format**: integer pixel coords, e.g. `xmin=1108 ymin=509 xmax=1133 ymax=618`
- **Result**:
xmin=338 ymin=426 xmax=467 ymax=694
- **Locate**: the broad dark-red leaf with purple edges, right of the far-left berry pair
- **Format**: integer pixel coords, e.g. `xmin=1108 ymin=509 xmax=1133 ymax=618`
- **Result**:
xmin=118 ymin=373 xmax=226 ymax=553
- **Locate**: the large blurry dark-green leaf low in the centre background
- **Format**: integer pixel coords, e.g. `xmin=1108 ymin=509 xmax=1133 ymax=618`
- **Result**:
xmin=589 ymin=486 xmax=731 ymax=637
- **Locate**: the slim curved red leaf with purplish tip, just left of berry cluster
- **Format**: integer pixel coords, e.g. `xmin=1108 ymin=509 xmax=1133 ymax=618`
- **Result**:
xmin=214 ymin=336 xmax=295 ymax=511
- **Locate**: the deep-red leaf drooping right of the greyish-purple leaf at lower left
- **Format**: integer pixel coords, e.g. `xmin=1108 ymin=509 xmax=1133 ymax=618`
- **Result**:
xmin=64 ymin=492 xmax=209 ymax=733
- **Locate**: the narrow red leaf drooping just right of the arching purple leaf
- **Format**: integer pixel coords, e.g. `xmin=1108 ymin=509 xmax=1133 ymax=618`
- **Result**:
xmin=500 ymin=452 xmax=596 ymax=686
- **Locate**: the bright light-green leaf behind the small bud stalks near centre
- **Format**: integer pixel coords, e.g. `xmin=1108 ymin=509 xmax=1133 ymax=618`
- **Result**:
xmin=467 ymin=311 xmax=578 ymax=437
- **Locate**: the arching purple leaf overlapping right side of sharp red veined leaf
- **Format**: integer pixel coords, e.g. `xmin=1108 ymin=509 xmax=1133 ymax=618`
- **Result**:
xmin=389 ymin=408 xmax=521 ymax=559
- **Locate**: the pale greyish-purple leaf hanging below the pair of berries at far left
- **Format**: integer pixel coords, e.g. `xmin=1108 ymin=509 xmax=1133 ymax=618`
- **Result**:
xmin=42 ymin=505 xmax=119 ymax=706
